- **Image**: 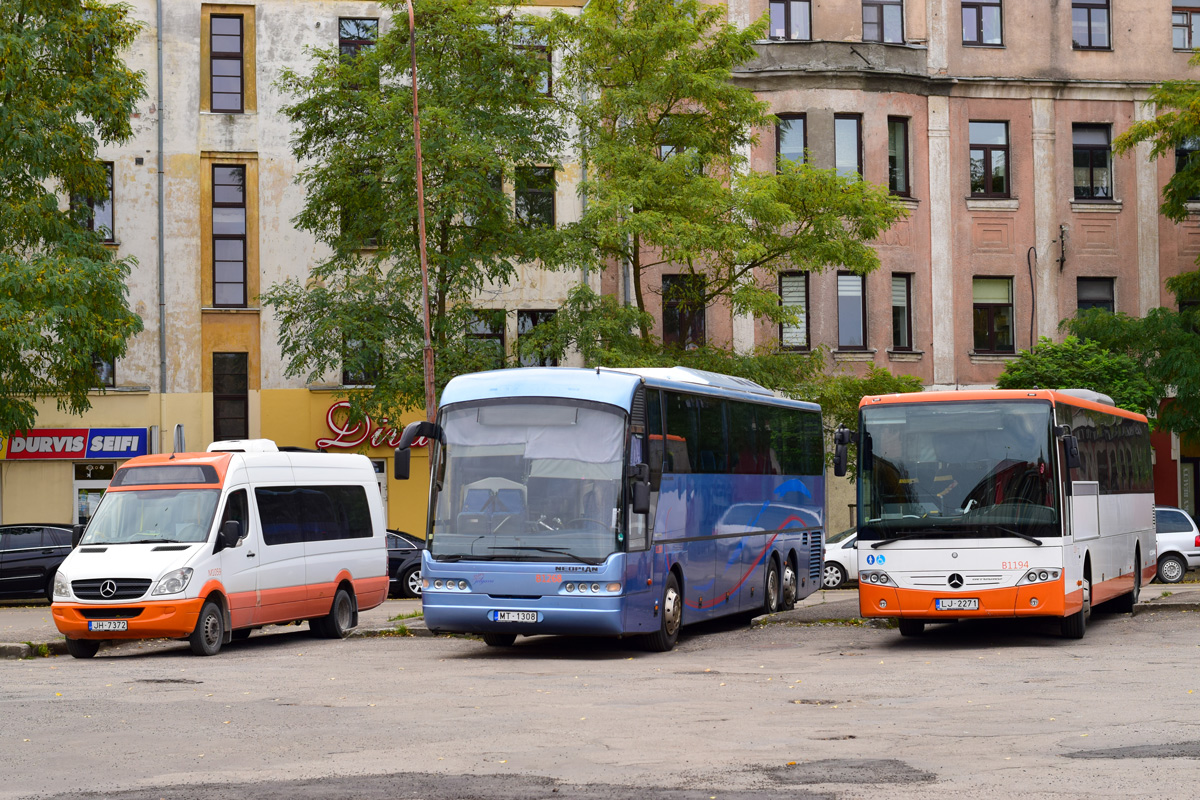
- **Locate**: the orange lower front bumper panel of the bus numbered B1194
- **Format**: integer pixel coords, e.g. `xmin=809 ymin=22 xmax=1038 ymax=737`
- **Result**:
xmin=858 ymin=578 xmax=1084 ymax=620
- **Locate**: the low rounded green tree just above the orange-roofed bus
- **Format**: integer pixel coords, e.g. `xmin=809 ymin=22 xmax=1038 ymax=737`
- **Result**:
xmin=996 ymin=336 xmax=1162 ymax=414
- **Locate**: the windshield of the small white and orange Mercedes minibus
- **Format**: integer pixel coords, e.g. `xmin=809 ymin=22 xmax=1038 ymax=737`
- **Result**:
xmin=79 ymin=489 xmax=221 ymax=545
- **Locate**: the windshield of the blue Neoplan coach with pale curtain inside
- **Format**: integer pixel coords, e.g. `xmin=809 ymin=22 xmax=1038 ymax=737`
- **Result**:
xmin=428 ymin=398 xmax=625 ymax=564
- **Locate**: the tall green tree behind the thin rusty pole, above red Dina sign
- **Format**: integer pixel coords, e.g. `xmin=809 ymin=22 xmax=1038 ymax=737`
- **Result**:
xmin=263 ymin=0 xmax=571 ymax=417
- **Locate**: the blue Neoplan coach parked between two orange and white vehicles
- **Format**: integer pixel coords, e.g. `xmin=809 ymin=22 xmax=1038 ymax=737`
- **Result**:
xmin=396 ymin=367 xmax=824 ymax=651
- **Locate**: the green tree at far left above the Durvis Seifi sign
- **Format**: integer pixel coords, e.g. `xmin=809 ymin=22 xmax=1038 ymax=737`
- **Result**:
xmin=0 ymin=0 xmax=145 ymax=434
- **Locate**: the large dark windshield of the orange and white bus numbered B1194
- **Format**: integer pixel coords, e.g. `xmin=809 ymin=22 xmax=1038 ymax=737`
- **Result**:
xmin=859 ymin=402 xmax=1061 ymax=541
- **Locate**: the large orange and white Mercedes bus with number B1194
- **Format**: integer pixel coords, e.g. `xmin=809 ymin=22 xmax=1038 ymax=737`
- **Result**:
xmin=835 ymin=390 xmax=1157 ymax=639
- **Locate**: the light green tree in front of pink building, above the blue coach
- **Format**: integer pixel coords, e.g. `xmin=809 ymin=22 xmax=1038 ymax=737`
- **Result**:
xmin=550 ymin=0 xmax=905 ymax=343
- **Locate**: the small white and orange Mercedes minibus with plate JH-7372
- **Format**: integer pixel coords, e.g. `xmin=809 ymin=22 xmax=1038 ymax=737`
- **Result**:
xmin=53 ymin=440 xmax=388 ymax=658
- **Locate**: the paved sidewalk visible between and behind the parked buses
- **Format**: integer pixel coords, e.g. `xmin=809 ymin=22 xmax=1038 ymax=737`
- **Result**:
xmin=0 ymin=583 xmax=1200 ymax=658
